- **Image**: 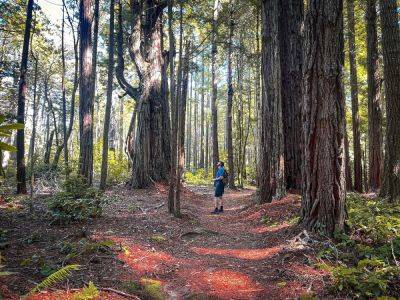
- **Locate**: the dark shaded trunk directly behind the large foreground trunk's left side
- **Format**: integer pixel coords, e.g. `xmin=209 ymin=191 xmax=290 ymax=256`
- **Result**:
xmin=279 ymin=0 xmax=304 ymax=190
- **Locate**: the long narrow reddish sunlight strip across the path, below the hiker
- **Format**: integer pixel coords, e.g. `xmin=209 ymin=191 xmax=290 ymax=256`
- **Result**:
xmin=191 ymin=246 xmax=282 ymax=260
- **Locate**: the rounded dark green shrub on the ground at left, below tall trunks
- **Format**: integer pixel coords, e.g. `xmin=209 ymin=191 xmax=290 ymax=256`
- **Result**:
xmin=47 ymin=176 xmax=103 ymax=223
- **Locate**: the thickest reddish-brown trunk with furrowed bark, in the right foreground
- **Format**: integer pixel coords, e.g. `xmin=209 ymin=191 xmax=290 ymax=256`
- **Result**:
xmin=302 ymin=0 xmax=346 ymax=235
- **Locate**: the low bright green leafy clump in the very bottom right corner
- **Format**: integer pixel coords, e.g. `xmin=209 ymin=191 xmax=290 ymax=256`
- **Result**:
xmin=333 ymin=259 xmax=400 ymax=298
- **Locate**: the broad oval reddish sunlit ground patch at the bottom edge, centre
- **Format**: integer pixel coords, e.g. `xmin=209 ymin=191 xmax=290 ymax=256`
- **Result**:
xmin=181 ymin=269 xmax=264 ymax=299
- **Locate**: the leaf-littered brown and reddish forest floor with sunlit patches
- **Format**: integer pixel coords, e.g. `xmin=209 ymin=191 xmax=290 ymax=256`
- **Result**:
xmin=0 ymin=185 xmax=329 ymax=299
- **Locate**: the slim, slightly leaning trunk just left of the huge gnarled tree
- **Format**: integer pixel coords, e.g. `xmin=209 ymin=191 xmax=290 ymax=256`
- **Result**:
xmin=100 ymin=0 xmax=114 ymax=190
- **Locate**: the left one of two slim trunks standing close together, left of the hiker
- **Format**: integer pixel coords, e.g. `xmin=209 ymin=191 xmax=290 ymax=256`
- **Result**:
xmin=168 ymin=0 xmax=177 ymax=214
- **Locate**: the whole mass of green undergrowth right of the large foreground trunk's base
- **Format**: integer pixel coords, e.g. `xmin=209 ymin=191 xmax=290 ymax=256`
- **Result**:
xmin=317 ymin=194 xmax=400 ymax=299
